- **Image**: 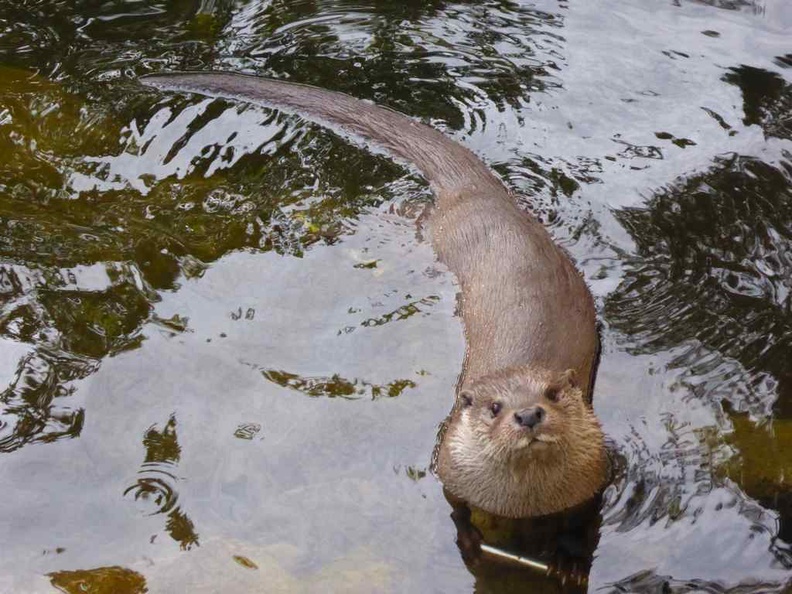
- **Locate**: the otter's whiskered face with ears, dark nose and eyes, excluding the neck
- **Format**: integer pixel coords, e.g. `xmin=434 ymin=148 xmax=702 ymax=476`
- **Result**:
xmin=456 ymin=370 xmax=593 ymax=462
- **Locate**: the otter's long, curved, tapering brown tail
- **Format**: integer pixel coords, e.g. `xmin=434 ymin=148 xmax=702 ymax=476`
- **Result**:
xmin=141 ymin=72 xmax=504 ymax=201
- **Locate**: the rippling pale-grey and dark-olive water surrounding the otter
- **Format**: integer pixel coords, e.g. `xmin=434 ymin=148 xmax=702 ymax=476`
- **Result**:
xmin=0 ymin=0 xmax=792 ymax=594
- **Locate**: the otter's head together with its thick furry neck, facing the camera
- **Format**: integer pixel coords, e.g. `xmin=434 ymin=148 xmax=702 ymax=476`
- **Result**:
xmin=437 ymin=367 xmax=606 ymax=517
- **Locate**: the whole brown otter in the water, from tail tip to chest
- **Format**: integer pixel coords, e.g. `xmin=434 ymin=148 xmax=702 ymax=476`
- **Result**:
xmin=141 ymin=72 xmax=606 ymax=517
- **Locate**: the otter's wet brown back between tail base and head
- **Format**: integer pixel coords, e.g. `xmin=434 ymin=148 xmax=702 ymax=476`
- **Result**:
xmin=428 ymin=188 xmax=597 ymax=384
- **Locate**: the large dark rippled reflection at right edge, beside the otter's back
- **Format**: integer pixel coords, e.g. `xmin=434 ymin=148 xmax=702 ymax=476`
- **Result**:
xmin=606 ymin=155 xmax=792 ymax=418
